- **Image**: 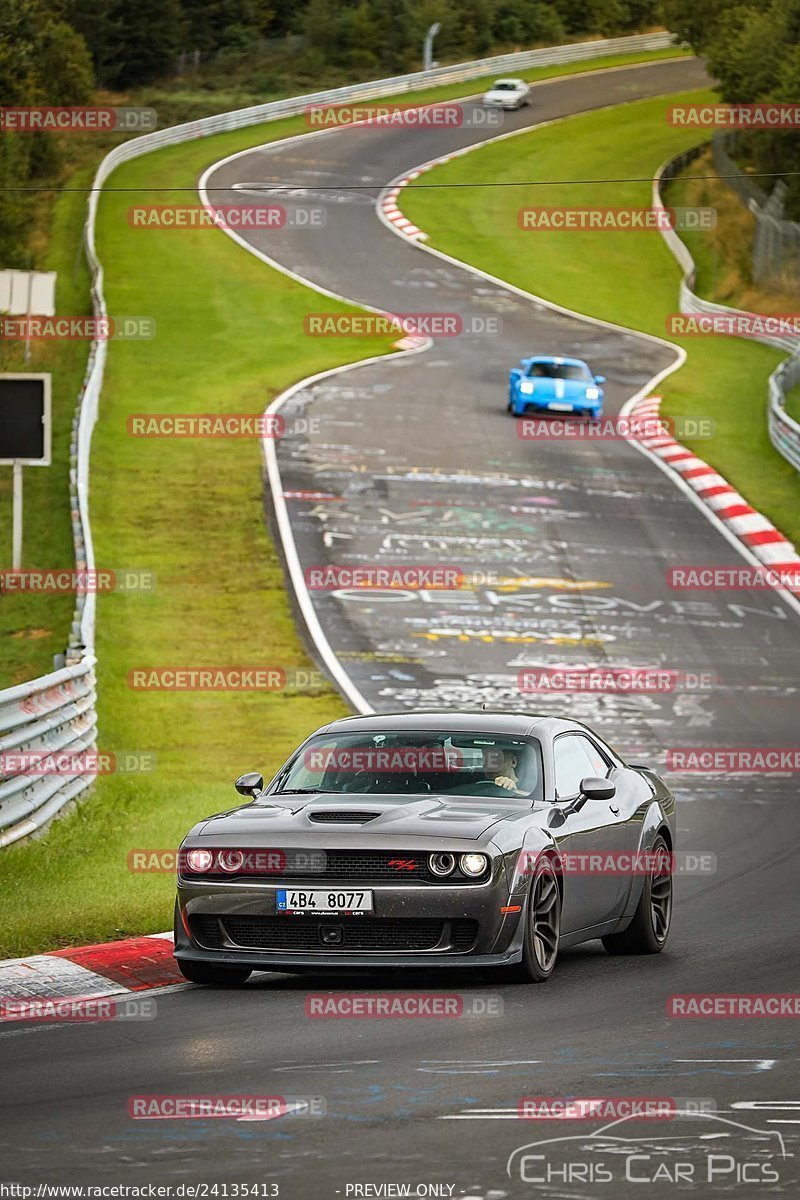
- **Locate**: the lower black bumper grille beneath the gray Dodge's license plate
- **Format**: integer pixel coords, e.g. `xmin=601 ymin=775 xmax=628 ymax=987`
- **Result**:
xmin=190 ymin=914 xmax=477 ymax=954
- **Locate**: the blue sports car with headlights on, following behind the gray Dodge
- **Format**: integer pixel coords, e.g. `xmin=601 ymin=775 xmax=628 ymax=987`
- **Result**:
xmin=509 ymin=354 xmax=606 ymax=420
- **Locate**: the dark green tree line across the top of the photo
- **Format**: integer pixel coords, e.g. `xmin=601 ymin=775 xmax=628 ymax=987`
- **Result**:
xmin=0 ymin=0 xmax=800 ymax=266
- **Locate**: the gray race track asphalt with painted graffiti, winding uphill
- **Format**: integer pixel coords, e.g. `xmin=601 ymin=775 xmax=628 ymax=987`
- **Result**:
xmin=0 ymin=60 xmax=800 ymax=1200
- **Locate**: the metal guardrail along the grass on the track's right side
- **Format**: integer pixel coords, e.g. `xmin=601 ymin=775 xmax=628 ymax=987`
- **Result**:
xmin=652 ymin=154 xmax=800 ymax=470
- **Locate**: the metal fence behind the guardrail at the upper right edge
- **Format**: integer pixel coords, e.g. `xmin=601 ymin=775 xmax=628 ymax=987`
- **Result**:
xmin=711 ymin=132 xmax=800 ymax=292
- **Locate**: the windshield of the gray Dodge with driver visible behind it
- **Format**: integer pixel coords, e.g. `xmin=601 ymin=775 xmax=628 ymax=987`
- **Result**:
xmin=276 ymin=730 xmax=543 ymax=804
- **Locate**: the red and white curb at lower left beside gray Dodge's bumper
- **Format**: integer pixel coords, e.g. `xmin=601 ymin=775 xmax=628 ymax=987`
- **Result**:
xmin=0 ymin=932 xmax=186 ymax=1025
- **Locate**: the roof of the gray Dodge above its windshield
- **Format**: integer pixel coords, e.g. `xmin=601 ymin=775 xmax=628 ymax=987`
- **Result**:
xmin=317 ymin=709 xmax=584 ymax=738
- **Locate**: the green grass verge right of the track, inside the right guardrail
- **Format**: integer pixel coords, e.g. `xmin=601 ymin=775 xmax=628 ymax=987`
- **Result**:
xmin=403 ymin=91 xmax=800 ymax=541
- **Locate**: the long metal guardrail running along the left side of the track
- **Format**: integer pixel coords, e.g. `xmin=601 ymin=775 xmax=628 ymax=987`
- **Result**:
xmin=0 ymin=32 xmax=674 ymax=847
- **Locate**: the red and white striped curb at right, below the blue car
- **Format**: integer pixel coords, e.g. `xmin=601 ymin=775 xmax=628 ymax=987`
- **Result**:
xmin=628 ymin=396 xmax=800 ymax=595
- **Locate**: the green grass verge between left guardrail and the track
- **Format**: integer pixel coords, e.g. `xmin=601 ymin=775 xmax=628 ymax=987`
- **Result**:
xmin=0 ymin=49 xmax=690 ymax=956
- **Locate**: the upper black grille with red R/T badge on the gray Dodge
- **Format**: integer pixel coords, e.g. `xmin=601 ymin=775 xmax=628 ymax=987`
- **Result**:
xmin=181 ymin=850 xmax=489 ymax=887
